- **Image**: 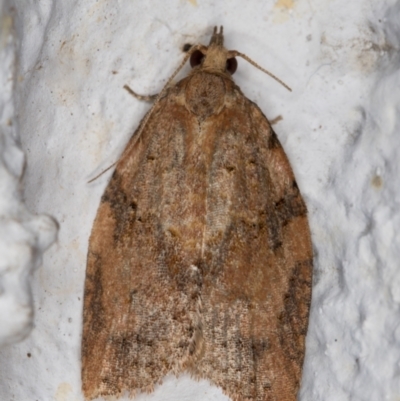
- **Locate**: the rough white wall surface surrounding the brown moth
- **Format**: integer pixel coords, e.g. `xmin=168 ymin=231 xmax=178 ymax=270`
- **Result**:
xmin=0 ymin=0 xmax=400 ymax=401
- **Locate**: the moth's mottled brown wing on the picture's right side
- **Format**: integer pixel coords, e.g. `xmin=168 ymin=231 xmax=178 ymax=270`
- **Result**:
xmin=187 ymin=91 xmax=312 ymax=401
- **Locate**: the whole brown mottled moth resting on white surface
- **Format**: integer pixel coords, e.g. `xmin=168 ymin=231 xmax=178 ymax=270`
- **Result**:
xmin=82 ymin=27 xmax=313 ymax=401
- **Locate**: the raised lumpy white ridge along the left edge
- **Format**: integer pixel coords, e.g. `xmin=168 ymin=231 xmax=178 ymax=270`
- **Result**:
xmin=0 ymin=1 xmax=56 ymax=346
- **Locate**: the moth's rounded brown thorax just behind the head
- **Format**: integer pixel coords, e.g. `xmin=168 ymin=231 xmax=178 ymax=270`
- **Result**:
xmin=185 ymin=71 xmax=229 ymax=120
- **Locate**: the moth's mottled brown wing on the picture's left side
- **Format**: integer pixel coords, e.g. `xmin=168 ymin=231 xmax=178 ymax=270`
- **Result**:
xmin=82 ymin=88 xmax=202 ymax=399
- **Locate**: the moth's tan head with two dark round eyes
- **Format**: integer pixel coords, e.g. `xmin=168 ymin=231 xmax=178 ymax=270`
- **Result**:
xmin=190 ymin=26 xmax=237 ymax=76
